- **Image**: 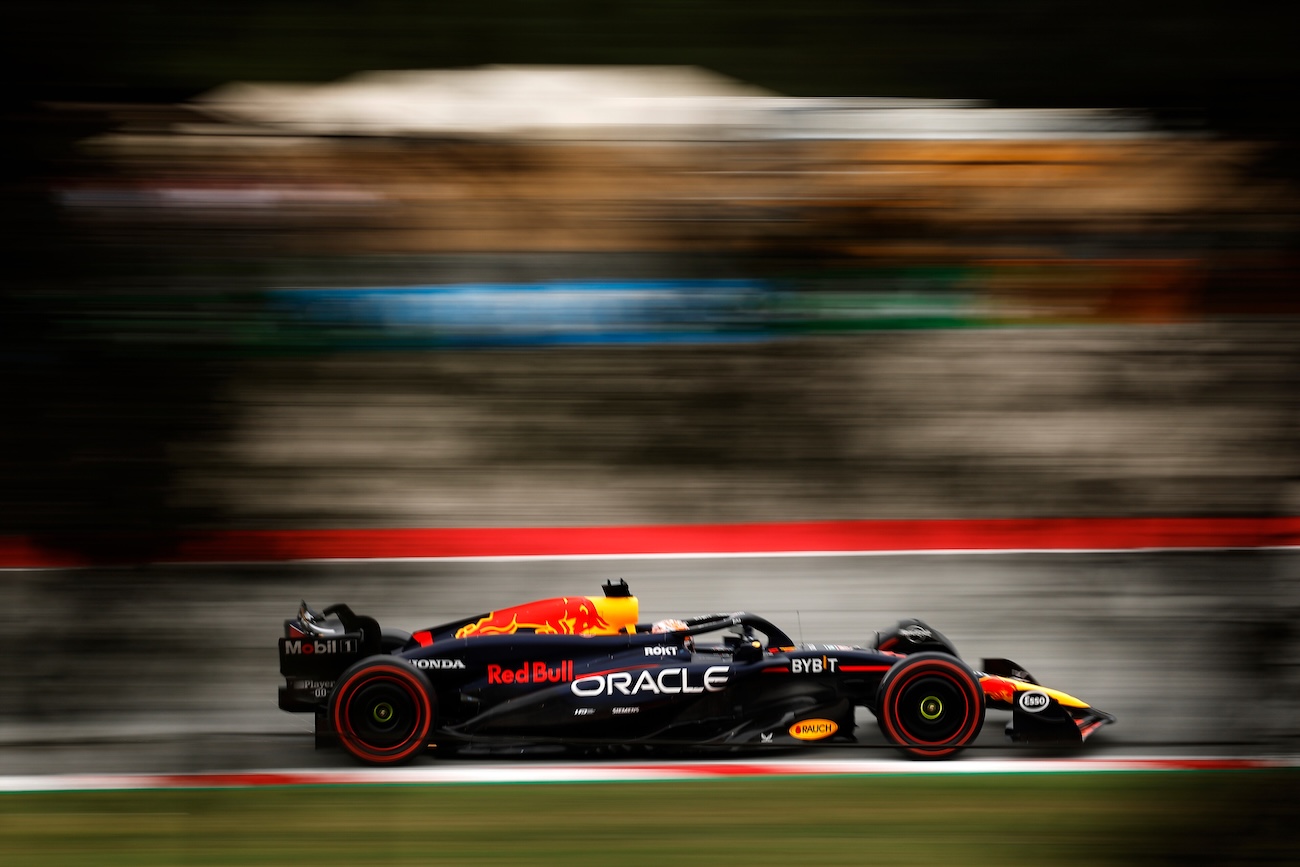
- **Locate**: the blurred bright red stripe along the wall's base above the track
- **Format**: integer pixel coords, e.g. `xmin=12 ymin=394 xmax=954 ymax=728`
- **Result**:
xmin=0 ymin=517 xmax=1300 ymax=569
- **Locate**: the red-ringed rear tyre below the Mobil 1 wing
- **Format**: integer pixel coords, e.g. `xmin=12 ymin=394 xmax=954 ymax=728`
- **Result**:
xmin=329 ymin=656 xmax=434 ymax=764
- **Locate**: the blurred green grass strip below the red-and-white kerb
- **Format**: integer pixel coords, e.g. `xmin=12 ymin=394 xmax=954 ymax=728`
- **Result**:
xmin=0 ymin=770 xmax=1300 ymax=867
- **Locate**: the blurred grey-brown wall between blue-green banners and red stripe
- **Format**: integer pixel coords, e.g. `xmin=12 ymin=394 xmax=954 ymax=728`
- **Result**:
xmin=185 ymin=324 xmax=1300 ymax=526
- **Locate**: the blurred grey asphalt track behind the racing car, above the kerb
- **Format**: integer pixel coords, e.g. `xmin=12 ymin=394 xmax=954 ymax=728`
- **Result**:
xmin=0 ymin=550 xmax=1300 ymax=775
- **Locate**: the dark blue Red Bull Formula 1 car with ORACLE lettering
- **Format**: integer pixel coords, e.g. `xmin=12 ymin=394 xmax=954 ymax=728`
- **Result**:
xmin=280 ymin=581 xmax=1114 ymax=764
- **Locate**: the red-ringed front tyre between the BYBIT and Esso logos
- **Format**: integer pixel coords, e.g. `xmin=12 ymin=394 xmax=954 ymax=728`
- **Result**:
xmin=876 ymin=653 xmax=984 ymax=759
